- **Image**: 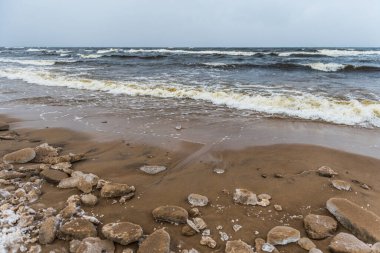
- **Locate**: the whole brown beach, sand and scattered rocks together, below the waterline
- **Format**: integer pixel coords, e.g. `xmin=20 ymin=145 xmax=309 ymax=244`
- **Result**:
xmin=0 ymin=118 xmax=380 ymax=253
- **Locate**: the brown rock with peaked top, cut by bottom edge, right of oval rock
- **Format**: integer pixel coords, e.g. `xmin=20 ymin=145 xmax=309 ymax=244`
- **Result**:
xmin=137 ymin=229 xmax=170 ymax=253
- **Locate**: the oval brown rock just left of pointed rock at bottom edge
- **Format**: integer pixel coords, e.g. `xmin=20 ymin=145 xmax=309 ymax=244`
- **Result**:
xmin=102 ymin=222 xmax=143 ymax=245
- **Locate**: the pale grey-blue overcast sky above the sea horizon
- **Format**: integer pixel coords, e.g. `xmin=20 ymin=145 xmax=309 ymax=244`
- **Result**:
xmin=0 ymin=0 xmax=380 ymax=47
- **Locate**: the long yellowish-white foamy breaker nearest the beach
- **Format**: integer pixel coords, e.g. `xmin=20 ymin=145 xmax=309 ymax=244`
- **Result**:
xmin=0 ymin=68 xmax=380 ymax=127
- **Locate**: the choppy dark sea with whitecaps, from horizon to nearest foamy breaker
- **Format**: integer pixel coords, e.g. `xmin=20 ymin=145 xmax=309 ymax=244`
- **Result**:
xmin=0 ymin=48 xmax=380 ymax=127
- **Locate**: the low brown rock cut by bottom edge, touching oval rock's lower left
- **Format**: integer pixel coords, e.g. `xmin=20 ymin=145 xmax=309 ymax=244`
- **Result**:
xmin=75 ymin=237 xmax=115 ymax=253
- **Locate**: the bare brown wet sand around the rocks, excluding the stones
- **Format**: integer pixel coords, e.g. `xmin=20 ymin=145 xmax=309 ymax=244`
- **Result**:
xmin=0 ymin=113 xmax=380 ymax=253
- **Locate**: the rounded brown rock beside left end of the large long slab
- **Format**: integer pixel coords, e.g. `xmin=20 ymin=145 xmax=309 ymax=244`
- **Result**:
xmin=303 ymin=214 xmax=338 ymax=240
